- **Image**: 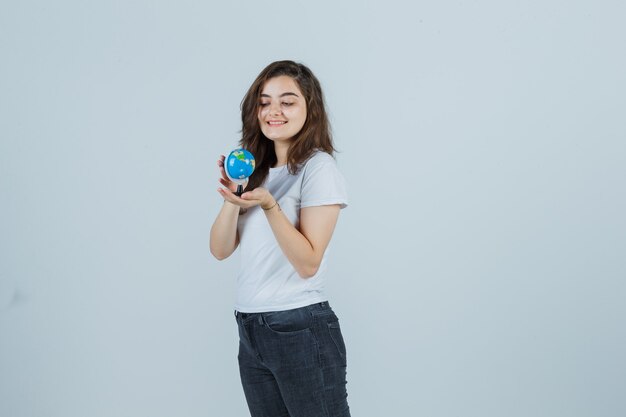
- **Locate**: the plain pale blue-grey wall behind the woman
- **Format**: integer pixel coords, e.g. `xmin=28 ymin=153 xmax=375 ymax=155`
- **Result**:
xmin=0 ymin=0 xmax=626 ymax=417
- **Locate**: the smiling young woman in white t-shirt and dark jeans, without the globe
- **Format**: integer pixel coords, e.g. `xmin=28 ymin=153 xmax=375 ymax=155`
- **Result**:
xmin=210 ymin=61 xmax=350 ymax=417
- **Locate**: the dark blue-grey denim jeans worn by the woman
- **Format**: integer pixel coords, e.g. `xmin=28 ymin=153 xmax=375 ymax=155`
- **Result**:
xmin=235 ymin=302 xmax=350 ymax=417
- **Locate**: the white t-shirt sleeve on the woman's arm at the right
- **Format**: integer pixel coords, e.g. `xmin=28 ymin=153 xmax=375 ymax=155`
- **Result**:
xmin=300 ymin=152 xmax=348 ymax=208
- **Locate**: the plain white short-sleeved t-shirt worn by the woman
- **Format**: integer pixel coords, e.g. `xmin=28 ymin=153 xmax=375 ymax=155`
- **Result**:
xmin=235 ymin=152 xmax=348 ymax=313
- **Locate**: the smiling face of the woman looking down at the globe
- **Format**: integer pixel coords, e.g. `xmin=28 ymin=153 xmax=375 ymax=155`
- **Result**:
xmin=258 ymin=75 xmax=306 ymax=142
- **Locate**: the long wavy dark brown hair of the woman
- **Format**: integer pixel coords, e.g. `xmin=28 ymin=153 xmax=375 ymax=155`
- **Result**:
xmin=239 ymin=61 xmax=335 ymax=190
